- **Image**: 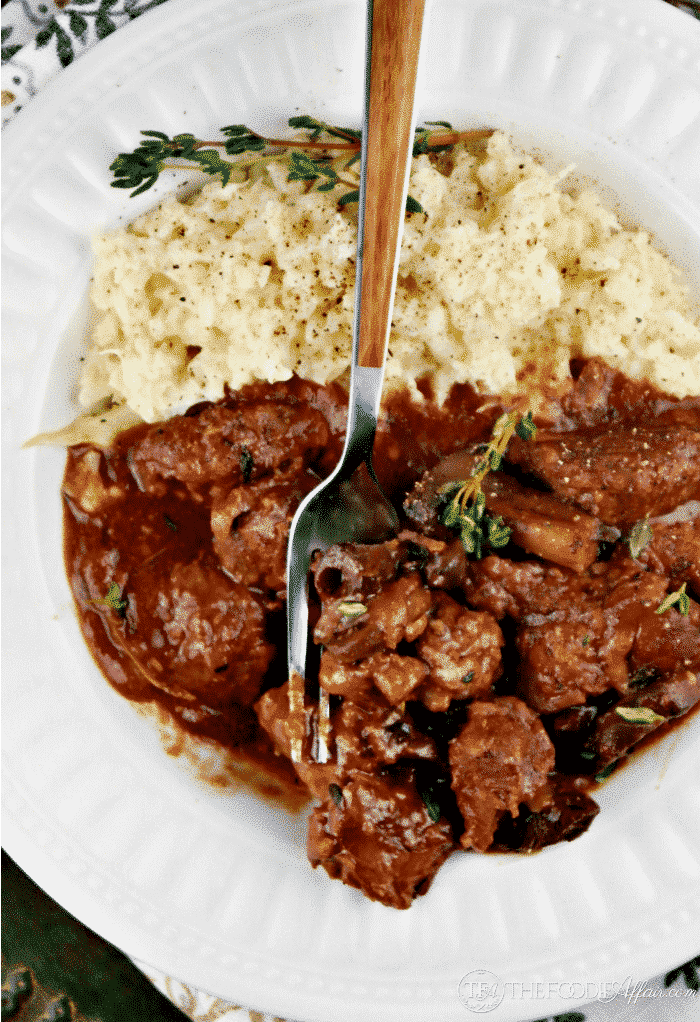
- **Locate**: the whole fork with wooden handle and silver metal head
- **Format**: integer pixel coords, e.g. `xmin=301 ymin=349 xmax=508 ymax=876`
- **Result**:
xmin=287 ymin=0 xmax=425 ymax=762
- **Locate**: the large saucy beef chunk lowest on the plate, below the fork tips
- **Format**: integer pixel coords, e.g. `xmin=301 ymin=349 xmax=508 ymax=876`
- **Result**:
xmin=307 ymin=774 xmax=455 ymax=909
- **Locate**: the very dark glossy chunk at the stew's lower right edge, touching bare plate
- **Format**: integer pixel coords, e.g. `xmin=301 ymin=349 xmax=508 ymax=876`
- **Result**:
xmin=492 ymin=778 xmax=600 ymax=851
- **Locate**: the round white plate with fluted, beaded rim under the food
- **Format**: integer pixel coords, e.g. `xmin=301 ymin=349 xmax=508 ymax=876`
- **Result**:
xmin=2 ymin=0 xmax=700 ymax=1022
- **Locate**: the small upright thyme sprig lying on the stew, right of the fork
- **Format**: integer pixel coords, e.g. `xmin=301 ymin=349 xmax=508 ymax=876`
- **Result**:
xmin=438 ymin=412 xmax=536 ymax=559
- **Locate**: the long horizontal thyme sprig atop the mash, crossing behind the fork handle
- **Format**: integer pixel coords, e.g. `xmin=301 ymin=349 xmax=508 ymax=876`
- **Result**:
xmin=109 ymin=114 xmax=492 ymax=204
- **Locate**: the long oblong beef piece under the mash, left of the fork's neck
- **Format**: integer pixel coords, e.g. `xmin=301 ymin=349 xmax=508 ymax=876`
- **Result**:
xmin=123 ymin=401 xmax=330 ymax=496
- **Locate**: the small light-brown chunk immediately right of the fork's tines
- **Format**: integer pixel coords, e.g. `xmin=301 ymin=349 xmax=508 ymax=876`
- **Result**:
xmin=319 ymin=650 xmax=428 ymax=706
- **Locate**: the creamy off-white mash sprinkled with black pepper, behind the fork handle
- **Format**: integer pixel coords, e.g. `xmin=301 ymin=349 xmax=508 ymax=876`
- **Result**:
xmin=80 ymin=133 xmax=700 ymax=421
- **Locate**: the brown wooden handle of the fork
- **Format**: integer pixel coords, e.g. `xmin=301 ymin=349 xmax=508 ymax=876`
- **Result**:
xmin=358 ymin=0 xmax=425 ymax=368
